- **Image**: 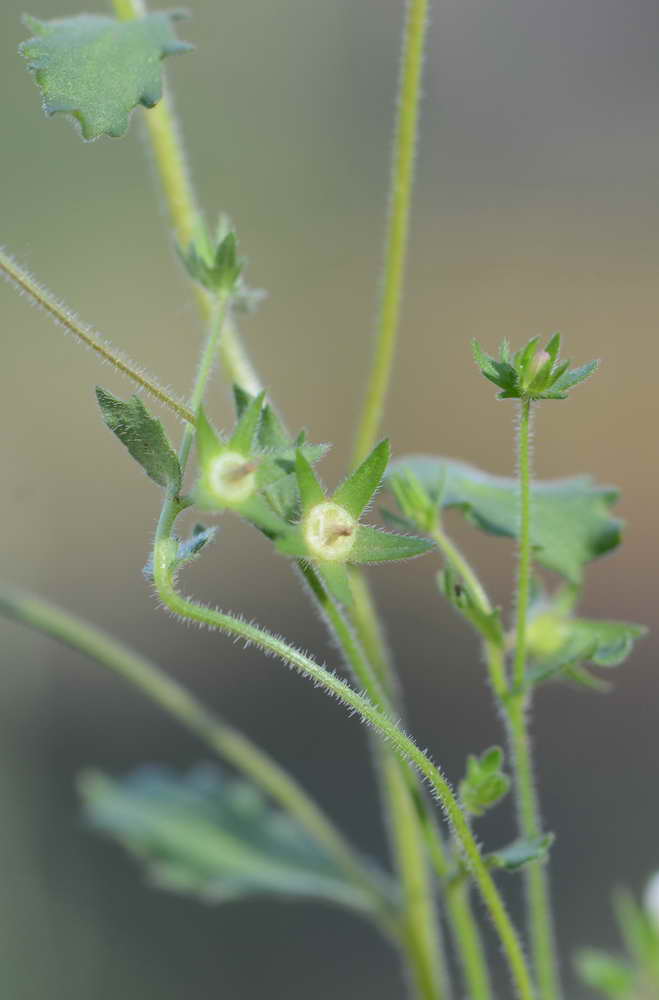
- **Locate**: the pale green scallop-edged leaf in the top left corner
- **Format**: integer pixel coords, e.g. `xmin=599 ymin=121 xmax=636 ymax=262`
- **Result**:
xmin=19 ymin=12 xmax=192 ymax=139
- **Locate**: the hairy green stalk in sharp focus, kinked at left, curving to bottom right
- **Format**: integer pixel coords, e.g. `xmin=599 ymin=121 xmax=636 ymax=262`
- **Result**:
xmin=154 ymin=524 xmax=535 ymax=1000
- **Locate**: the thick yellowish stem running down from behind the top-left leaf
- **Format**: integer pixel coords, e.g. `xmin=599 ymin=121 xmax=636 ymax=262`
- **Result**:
xmin=113 ymin=0 xmax=261 ymax=395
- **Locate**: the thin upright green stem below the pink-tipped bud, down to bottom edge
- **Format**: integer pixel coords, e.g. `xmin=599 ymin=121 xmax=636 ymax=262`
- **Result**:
xmin=505 ymin=398 xmax=562 ymax=1000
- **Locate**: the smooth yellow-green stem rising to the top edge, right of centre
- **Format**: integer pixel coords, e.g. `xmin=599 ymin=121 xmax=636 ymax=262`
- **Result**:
xmin=353 ymin=0 xmax=430 ymax=465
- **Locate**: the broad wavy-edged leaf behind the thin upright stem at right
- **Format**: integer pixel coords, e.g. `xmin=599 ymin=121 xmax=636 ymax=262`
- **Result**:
xmin=388 ymin=455 xmax=621 ymax=583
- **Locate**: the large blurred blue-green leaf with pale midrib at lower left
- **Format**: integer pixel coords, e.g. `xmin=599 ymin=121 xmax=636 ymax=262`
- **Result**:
xmin=79 ymin=766 xmax=384 ymax=910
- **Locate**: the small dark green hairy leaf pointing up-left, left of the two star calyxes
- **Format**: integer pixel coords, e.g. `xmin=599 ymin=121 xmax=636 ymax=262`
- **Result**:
xmin=96 ymin=386 xmax=181 ymax=493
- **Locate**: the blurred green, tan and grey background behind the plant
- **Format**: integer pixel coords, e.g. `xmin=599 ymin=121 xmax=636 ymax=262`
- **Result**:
xmin=0 ymin=0 xmax=659 ymax=1000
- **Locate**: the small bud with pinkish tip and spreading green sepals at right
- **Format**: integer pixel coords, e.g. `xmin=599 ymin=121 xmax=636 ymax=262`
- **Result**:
xmin=472 ymin=333 xmax=598 ymax=400
